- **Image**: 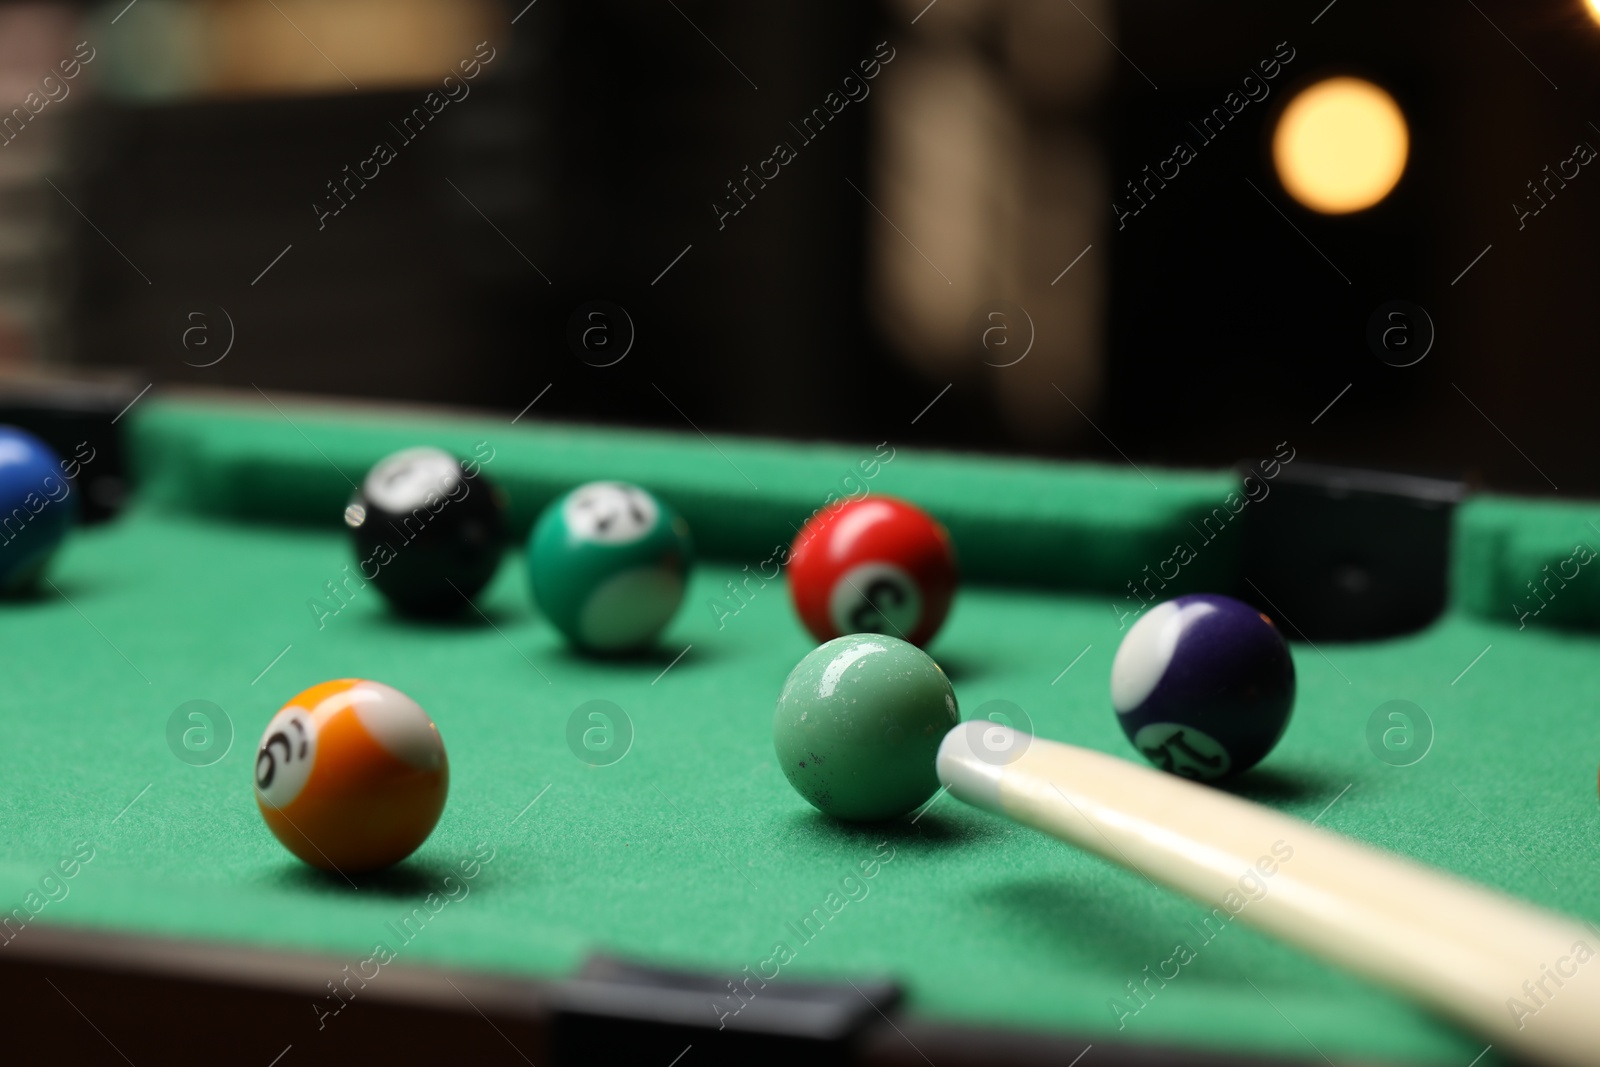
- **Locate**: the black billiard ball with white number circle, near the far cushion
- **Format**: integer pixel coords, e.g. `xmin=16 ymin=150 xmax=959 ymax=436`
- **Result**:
xmin=344 ymin=446 xmax=506 ymax=616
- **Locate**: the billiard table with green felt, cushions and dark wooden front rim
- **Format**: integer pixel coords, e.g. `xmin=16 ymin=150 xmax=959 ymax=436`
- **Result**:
xmin=0 ymin=394 xmax=1600 ymax=1067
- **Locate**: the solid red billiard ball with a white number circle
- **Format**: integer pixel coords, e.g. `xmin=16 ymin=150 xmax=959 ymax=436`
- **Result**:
xmin=789 ymin=496 xmax=957 ymax=645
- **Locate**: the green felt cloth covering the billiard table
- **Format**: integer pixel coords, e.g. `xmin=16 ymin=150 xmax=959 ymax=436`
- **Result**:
xmin=0 ymin=396 xmax=1600 ymax=1064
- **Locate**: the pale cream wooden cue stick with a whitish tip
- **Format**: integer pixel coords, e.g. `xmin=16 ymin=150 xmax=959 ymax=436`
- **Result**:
xmin=938 ymin=720 xmax=1600 ymax=1065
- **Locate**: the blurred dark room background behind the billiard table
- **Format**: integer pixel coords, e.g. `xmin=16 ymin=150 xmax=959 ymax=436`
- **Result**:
xmin=0 ymin=0 xmax=1600 ymax=494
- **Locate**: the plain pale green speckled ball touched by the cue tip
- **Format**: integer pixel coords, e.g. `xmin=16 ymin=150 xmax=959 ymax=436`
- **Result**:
xmin=773 ymin=633 xmax=960 ymax=821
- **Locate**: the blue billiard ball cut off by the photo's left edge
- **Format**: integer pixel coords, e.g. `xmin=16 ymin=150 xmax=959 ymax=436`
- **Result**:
xmin=0 ymin=426 xmax=78 ymax=595
